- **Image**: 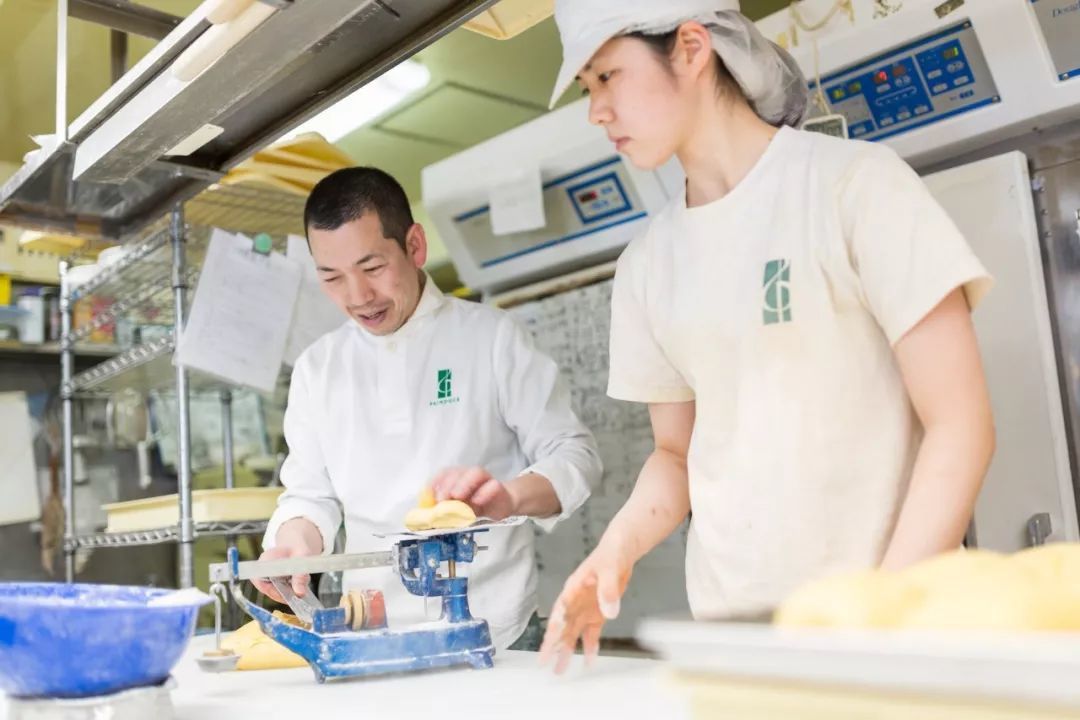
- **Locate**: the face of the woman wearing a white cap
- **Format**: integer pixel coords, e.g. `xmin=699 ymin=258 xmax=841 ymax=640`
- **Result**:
xmin=578 ymin=38 xmax=694 ymax=169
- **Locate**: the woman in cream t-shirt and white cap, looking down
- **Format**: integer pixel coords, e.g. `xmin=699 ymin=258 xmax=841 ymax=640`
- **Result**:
xmin=544 ymin=0 xmax=994 ymax=670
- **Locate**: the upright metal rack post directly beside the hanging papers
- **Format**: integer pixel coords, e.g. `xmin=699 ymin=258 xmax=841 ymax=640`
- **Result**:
xmin=170 ymin=205 xmax=195 ymax=587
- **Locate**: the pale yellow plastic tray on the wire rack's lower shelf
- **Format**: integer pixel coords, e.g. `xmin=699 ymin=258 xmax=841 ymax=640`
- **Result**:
xmin=104 ymin=488 xmax=283 ymax=532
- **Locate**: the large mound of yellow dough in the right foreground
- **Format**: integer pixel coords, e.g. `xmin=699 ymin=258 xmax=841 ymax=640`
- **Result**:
xmin=773 ymin=543 xmax=1080 ymax=630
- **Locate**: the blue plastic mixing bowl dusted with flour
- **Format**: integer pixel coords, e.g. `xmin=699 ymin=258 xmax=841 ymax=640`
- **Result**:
xmin=0 ymin=583 xmax=204 ymax=697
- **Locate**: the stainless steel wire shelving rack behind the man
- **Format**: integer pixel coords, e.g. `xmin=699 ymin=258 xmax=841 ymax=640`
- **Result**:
xmin=60 ymin=186 xmax=303 ymax=587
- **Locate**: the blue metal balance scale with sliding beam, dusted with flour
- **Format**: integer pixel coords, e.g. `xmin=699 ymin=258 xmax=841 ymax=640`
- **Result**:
xmin=200 ymin=518 xmax=509 ymax=682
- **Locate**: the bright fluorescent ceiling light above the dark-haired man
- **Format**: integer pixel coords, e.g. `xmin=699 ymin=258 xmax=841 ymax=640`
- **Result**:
xmin=288 ymin=60 xmax=431 ymax=142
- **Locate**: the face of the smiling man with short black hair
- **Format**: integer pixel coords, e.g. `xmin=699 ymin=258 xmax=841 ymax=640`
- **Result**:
xmin=308 ymin=212 xmax=428 ymax=335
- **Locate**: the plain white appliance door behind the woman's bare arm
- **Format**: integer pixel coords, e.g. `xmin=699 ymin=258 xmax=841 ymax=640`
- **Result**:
xmin=923 ymin=152 xmax=1078 ymax=552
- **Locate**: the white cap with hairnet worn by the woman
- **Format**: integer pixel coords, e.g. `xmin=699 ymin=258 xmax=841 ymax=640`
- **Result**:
xmin=551 ymin=0 xmax=809 ymax=126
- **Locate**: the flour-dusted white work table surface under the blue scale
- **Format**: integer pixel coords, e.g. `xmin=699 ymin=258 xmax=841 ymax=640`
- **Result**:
xmin=0 ymin=637 xmax=689 ymax=720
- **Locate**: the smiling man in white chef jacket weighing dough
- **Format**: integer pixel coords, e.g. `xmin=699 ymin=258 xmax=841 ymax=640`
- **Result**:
xmin=259 ymin=167 xmax=602 ymax=649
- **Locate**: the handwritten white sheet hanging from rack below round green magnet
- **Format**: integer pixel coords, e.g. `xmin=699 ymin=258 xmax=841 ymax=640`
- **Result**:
xmin=175 ymin=230 xmax=302 ymax=392
